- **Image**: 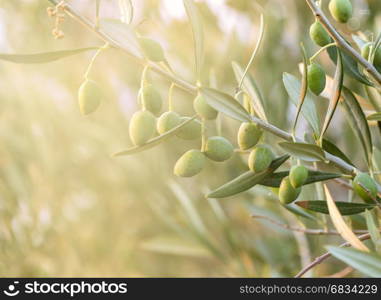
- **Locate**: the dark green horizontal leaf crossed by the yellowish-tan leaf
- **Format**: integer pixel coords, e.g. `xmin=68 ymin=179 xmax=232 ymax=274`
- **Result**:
xmin=295 ymin=200 xmax=375 ymax=216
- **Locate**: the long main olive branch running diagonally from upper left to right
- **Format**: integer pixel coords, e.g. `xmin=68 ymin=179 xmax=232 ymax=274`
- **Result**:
xmin=44 ymin=0 xmax=372 ymax=182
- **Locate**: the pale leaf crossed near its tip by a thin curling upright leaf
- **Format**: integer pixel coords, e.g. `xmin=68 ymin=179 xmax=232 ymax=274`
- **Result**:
xmin=232 ymin=61 xmax=267 ymax=121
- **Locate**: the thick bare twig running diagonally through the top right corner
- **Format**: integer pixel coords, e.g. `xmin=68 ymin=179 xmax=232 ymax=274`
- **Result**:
xmin=306 ymin=0 xmax=381 ymax=85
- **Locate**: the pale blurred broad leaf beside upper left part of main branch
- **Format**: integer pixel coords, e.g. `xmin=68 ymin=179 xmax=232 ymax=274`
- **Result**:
xmin=99 ymin=18 xmax=142 ymax=57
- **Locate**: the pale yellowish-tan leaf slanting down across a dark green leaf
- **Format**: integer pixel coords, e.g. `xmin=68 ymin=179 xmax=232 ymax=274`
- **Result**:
xmin=324 ymin=185 xmax=369 ymax=251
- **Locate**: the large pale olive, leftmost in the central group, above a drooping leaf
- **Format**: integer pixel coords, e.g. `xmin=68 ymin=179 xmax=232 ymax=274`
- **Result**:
xmin=129 ymin=110 xmax=156 ymax=145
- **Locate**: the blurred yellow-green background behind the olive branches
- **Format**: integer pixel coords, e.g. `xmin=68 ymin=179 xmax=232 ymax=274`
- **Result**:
xmin=0 ymin=0 xmax=381 ymax=277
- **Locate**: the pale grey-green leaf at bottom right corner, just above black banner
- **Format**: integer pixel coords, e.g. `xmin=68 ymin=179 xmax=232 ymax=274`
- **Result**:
xmin=327 ymin=246 xmax=381 ymax=278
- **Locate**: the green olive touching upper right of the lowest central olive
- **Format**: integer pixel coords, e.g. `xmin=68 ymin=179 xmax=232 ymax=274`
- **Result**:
xmin=205 ymin=136 xmax=234 ymax=161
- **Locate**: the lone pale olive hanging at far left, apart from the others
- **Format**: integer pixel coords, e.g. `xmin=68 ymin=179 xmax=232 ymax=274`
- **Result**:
xmin=78 ymin=79 xmax=103 ymax=115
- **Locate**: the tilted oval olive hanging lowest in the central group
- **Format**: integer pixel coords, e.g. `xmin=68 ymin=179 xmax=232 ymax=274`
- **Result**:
xmin=173 ymin=149 xmax=205 ymax=177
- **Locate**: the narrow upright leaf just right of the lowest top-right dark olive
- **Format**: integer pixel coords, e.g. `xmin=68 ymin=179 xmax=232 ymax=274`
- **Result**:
xmin=320 ymin=50 xmax=344 ymax=144
